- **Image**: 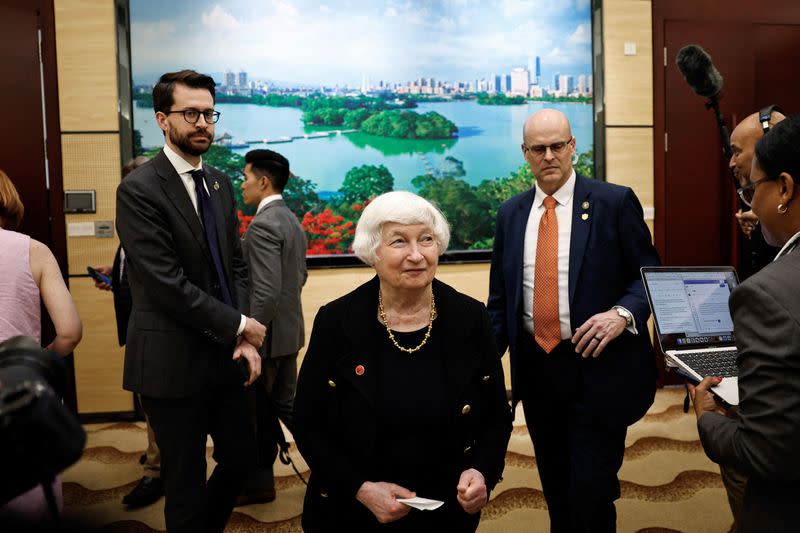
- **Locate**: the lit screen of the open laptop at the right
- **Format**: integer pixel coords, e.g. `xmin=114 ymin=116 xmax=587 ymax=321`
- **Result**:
xmin=642 ymin=267 xmax=738 ymax=352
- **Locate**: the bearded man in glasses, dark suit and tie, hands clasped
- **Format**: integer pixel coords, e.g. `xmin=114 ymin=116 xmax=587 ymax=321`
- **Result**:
xmin=117 ymin=70 xmax=265 ymax=533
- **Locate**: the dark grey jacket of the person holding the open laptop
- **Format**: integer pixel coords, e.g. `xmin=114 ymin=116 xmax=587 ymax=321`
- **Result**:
xmin=698 ymin=251 xmax=800 ymax=531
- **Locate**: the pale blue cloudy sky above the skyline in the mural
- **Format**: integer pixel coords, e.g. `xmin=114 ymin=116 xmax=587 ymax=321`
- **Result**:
xmin=130 ymin=0 xmax=592 ymax=87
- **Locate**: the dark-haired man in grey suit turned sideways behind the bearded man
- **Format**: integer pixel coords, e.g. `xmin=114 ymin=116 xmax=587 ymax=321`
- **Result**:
xmin=238 ymin=150 xmax=308 ymax=505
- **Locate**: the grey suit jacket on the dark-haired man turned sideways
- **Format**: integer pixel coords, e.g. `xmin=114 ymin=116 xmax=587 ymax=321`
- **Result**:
xmin=242 ymin=200 xmax=308 ymax=357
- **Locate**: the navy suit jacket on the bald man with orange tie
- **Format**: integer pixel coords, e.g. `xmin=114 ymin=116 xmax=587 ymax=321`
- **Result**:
xmin=487 ymin=176 xmax=660 ymax=425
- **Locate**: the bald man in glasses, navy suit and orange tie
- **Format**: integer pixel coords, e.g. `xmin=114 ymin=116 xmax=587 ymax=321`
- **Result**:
xmin=488 ymin=109 xmax=659 ymax=533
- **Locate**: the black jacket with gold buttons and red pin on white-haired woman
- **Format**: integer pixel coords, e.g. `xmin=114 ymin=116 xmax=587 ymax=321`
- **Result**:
xmin=294 ymin=277 xmax=511 ymax=531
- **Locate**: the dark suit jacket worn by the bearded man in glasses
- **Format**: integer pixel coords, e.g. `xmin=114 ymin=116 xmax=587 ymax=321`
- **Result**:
xmin=117 ymin=151 xmax=248 ymax=398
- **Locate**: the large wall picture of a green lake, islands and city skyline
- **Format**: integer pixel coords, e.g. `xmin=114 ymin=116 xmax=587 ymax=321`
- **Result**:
xmin=130 ymin=0 xmax=593 ymax=256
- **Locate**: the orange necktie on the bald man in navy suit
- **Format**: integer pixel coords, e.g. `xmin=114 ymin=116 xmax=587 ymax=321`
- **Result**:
xmin=533 ymin=196 xmax=561 ymax=353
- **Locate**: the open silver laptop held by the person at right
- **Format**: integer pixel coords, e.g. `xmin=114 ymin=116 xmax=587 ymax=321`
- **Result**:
xmin=642 ymin=267 xmax=739 ymax=405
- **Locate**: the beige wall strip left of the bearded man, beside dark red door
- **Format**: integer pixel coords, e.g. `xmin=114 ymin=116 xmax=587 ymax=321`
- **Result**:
xmin=54 ymin=0 xmax=133 ymax=413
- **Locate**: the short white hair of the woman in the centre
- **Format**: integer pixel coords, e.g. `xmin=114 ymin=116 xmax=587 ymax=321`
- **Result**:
xmin=353 ymin=191 xmax=450 ymax=266
